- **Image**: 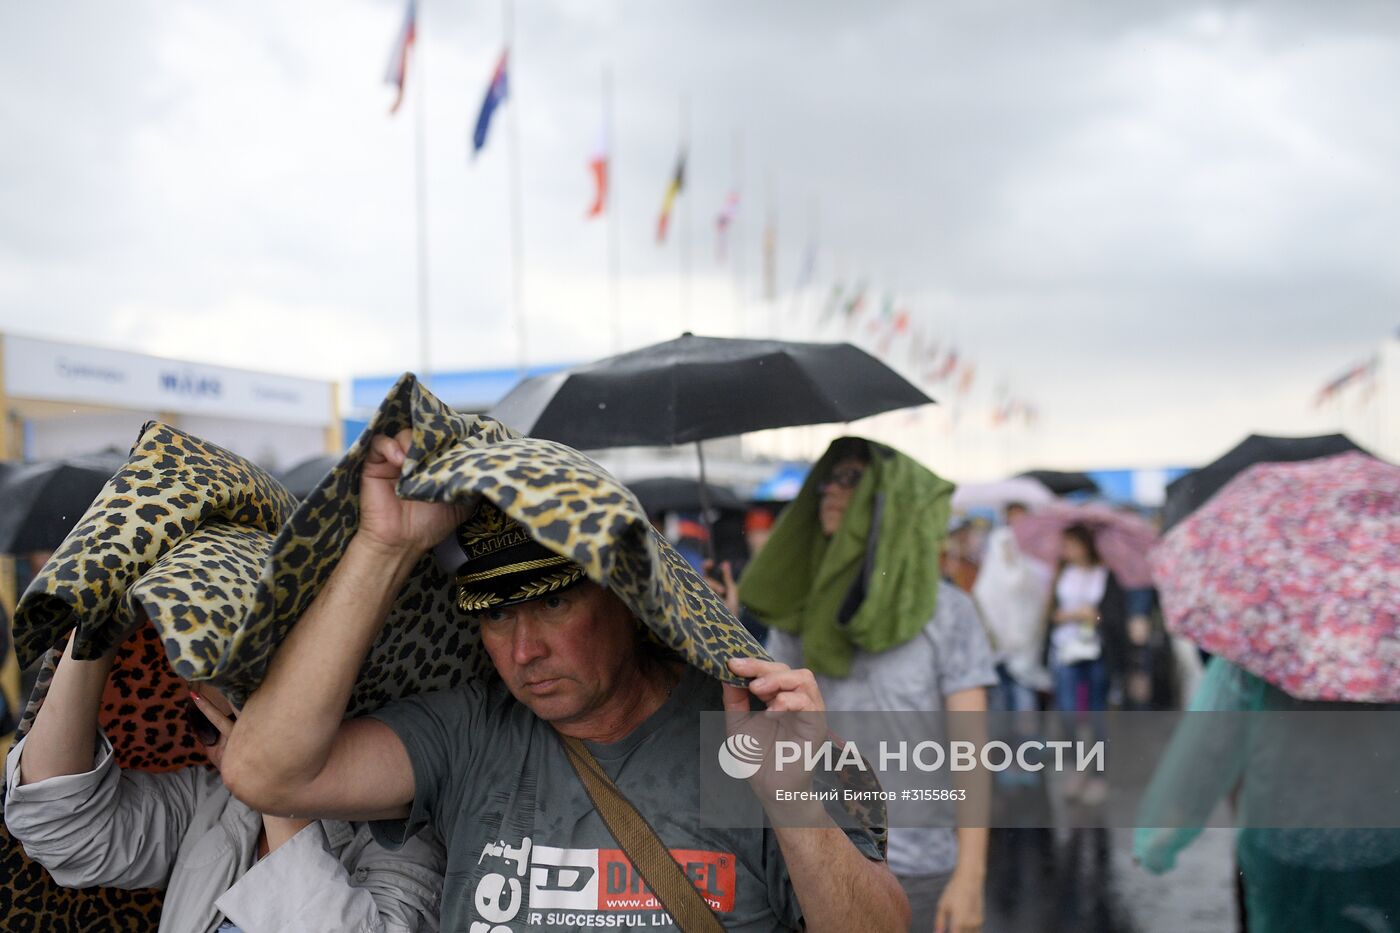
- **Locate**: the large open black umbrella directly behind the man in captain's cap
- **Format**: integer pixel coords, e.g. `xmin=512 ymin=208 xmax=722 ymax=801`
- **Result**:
xmin=491 ymin=333 xmax=934 ymax=450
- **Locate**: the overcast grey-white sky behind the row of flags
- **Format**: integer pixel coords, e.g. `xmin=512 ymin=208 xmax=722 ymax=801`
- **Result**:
xmin=0 ymin=0 xmax=1400 ymax=478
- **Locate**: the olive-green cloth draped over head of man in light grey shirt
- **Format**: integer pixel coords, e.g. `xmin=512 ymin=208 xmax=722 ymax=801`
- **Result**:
xmin=739 ymin=438 xmax=953 ymax=677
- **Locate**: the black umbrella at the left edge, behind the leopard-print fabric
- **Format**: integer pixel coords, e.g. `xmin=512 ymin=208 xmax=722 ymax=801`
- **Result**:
xmin=0 ymin=450 xmax=126 ymax=553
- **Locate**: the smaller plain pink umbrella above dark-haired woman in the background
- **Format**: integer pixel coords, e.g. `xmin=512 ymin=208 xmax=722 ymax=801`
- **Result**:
xmin=1011 ymin=502 xmax=1156 ymax=590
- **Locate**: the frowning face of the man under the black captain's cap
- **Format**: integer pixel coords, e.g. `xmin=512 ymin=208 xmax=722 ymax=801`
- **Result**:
xmin=477 ymin=581 xmax=640 ymax=724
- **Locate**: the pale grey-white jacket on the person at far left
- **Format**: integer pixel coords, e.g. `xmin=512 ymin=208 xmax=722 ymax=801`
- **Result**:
xmin=4 ymin=733 xmax=445 ymax=933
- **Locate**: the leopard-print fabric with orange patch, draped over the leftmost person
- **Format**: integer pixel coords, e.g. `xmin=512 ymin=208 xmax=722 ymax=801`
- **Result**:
xmin=0 ymin=423 xmax=281 ymax=933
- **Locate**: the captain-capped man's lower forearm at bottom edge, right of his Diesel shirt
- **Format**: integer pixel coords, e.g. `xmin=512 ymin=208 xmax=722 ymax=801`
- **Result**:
xmin=774 ymin=811 xmax=909 ymax=933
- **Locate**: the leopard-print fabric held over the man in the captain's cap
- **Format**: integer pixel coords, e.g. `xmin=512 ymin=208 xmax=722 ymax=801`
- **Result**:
xmin=229 ymin=375 xmax=767 ymax=713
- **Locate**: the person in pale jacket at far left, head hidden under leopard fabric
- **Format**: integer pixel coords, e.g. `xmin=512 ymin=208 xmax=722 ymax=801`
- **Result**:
xmin=4 ymin=619 xmax=445 ymax=933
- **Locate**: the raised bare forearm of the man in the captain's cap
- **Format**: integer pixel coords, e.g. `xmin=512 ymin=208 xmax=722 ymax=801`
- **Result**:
xmin=224 ymin=537 xmax=417 ymax=790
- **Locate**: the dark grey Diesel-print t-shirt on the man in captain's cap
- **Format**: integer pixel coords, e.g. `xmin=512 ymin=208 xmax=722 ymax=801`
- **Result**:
xmin=374 ymin=668 xmax=878 ymax=933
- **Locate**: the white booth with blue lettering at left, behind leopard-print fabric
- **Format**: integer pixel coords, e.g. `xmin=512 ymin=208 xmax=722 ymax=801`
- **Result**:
xmin=0 ymin=335 xmax=342 ymax=471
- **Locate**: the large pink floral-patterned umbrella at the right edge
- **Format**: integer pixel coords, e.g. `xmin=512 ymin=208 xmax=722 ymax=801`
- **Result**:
xmin=1152 ymin=454 xmax=1400 ymax=703
